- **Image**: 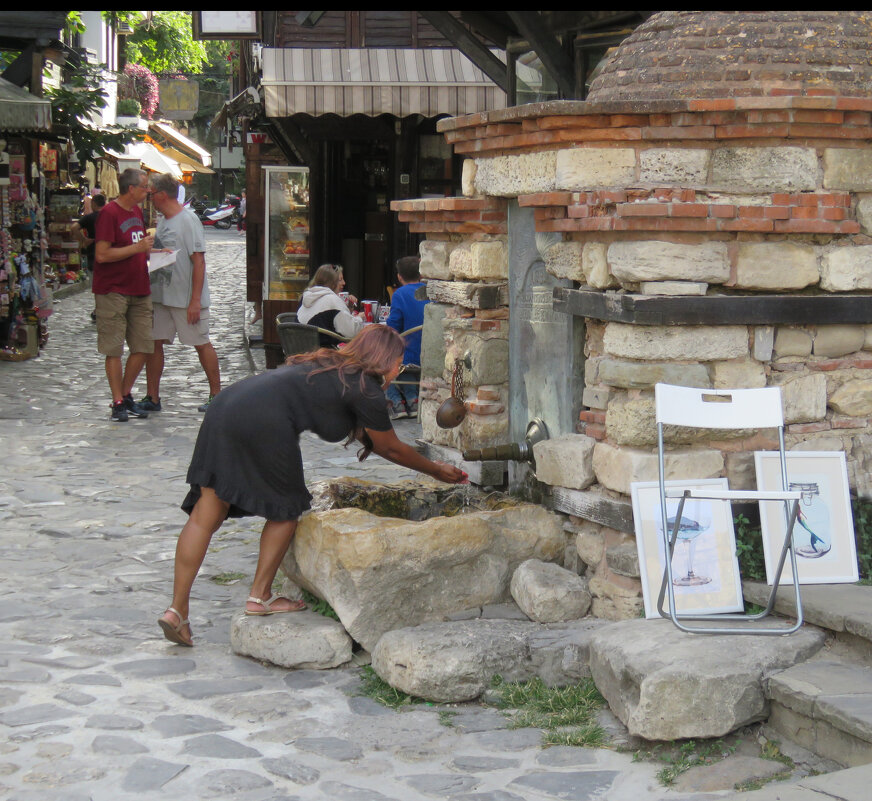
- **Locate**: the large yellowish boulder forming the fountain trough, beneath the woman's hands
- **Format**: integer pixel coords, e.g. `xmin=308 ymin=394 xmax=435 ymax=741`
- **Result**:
xmin=282 ymin=504 xmax=566 ymax=651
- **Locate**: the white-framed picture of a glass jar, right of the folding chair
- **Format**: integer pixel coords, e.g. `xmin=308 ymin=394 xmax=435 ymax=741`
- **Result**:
xmin=754 ymin=451 xmax=860 ymax=584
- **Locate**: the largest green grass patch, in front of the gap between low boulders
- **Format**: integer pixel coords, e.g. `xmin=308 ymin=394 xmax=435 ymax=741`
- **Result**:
xmin=491 ymin=676 xmax=607 ymax=747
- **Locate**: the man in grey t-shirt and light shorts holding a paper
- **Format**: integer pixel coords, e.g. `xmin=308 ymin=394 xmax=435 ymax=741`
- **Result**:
xmin=139 ymin=173 xmax=221 ymax=412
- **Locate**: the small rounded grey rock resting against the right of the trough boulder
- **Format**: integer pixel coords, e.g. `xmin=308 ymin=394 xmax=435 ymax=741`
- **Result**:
xmin=509 ymin=559 xmax=590 ymax=623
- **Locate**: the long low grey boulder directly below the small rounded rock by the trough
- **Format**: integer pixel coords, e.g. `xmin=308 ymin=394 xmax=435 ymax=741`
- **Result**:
xmin=372 ymin=618 xmax=608 ymax=703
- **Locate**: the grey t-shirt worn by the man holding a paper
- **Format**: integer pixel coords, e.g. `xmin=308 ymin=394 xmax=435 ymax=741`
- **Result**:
xmin=151 ymin=209 xmax=209 ymax=309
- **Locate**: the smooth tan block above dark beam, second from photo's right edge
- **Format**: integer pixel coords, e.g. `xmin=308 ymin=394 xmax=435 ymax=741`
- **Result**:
xmin=735 ymin=242 xmax=820 ymax=289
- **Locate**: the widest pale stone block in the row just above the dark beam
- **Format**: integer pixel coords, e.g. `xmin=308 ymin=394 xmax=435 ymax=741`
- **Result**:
xmin=608 ymin=241 xmax=730 ymax=284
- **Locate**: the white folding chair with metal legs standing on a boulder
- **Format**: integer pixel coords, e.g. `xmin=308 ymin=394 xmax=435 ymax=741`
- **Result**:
xmin=654 ymin=384 xmax=802 ymax=635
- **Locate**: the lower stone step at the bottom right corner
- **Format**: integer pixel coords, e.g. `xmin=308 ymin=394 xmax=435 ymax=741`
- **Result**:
xmin=766 ymin=659 xmax=872 ymax=767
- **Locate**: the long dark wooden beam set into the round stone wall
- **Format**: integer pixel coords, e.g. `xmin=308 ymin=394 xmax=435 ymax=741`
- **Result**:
xmin=552 ymin=287 xmax=872 ymax=325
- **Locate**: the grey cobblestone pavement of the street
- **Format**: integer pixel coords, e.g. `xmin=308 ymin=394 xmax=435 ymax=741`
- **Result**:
xmin=0 ymin=231 xmax=700 ymax=801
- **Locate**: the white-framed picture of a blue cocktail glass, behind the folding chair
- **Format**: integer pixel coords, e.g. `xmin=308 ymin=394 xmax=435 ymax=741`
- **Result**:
xmin=630 ymin=478 xmax=745 ymax=618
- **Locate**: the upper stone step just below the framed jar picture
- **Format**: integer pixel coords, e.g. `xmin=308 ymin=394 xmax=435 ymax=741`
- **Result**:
xmin=742 ymin=581 xmax=872 ymax=662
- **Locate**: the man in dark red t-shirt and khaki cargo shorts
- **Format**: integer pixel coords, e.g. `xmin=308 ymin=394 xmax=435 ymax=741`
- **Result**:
xmin=92 ymin=169 xmax=154 ymax=423
